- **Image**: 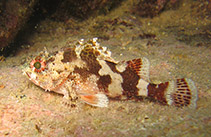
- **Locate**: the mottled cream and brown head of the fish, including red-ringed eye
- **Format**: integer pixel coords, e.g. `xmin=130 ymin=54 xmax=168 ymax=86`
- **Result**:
xmin=23 ymin=48 xmax=80 ymax=91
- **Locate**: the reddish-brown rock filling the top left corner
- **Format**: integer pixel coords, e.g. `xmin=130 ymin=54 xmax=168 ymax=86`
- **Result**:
xmin=0 ymin=0 xmax=37 ymax=55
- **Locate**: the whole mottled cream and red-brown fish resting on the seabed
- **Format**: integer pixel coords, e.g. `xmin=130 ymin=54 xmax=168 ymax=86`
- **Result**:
xmin=23 ymin=38 xmax=198 ymax=108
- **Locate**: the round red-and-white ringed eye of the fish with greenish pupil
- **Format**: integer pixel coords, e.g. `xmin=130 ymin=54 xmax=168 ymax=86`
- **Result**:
xmin=30 ymin=58 xmax=46 ymax=72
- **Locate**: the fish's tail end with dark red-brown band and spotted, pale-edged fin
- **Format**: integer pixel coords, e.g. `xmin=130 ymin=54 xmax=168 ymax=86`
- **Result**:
xmin=147 ymin=78 xmax=198 ymax=108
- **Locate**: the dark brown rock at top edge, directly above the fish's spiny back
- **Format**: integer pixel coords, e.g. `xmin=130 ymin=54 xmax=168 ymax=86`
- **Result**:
xmin=51 ymin=0 xmax=123 ymax=20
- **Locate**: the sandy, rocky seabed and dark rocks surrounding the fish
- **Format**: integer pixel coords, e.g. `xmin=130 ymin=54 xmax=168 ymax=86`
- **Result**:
xmin=0 ymin=0 xmax=211 ymax=137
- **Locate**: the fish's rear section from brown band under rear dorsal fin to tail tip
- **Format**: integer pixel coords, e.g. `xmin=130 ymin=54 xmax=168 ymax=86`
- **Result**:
xmin=122 ymin=58 xmax=198 ymax=107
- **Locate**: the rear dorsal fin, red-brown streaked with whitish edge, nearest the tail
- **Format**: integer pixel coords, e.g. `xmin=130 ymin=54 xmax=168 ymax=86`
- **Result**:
xmin=127 ymin=57 xmax=150 ymax=82
